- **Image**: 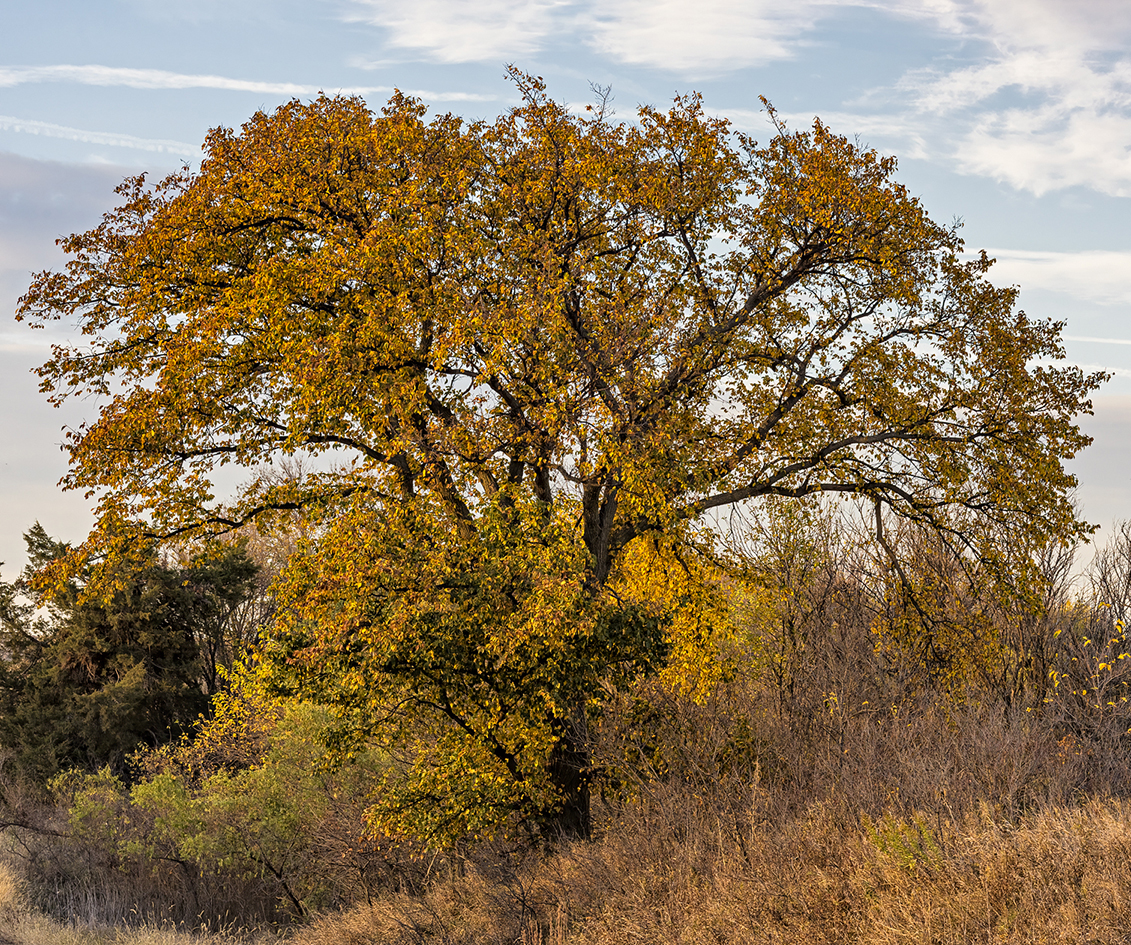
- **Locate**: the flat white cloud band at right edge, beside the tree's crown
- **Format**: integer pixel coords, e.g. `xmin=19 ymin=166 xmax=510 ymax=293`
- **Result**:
xmin=986 ymin=250 xmax=1131 ymax=305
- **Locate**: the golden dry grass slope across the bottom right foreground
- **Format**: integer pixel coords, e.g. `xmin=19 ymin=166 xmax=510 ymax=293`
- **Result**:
xmin=294 ymin=800 xmax=1131 ymax=945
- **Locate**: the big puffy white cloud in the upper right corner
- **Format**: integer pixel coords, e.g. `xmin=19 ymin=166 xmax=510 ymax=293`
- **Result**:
xmin=899 ymin=0 xmax=1131 ymax=196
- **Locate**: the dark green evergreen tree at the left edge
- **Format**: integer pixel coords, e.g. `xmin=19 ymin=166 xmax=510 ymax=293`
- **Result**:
xmin=0 ymin=524 xmax=254 ymax=780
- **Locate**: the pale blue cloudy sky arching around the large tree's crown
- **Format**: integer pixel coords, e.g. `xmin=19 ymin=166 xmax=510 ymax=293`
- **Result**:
xmin=0 ymin=0 xmax=1131 ymax=580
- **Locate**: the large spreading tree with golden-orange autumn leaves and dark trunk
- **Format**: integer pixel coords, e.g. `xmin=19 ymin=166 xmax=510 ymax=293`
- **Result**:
xmin=13 ymin=73 xmax=1102 ymax=826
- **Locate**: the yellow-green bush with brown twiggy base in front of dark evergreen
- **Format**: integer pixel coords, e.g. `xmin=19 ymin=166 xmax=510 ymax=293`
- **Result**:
xmin=6 ymin=686 xmax=411 ymax=927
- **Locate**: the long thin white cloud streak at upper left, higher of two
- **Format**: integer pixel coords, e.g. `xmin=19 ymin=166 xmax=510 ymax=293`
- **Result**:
xmin=0 ymin=64 xmax=495 ymax=102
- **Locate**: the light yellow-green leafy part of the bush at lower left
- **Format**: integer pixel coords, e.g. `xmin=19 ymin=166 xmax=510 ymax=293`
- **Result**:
xmin=51 ymin=691 xmax=389 ymax=916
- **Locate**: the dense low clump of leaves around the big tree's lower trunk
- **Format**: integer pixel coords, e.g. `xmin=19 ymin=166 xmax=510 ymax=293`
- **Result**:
xmin=261 ymin=500 xmax=666 ymax=843
